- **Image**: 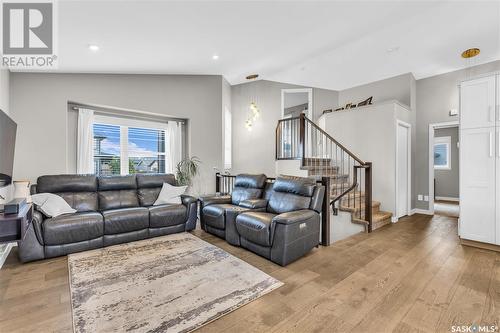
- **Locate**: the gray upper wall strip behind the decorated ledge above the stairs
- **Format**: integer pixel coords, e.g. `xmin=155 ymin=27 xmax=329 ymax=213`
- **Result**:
xmin=339 ymin=73 xmax=415 ymax=109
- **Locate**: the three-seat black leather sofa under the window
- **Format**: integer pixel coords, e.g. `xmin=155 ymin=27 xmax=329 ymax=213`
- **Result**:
xmin=19 ymin=174 xmax=197 ymax=262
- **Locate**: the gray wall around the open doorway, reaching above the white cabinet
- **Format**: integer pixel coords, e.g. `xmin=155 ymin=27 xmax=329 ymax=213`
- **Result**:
xmin=413 ymin=61 xmax=500 ymax=210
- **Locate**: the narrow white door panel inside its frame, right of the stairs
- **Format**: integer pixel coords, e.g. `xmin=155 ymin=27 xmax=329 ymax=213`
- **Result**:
xmin=396 ymin=124 xmax=410 ymax=218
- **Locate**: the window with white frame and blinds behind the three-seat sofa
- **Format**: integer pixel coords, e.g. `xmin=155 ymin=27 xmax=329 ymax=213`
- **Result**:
xmin=93 ymin=116 xmax=167 ymax=175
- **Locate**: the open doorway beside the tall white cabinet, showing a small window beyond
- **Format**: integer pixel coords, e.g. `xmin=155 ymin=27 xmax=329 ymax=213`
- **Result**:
xmin=429 ymin=121 xmax=460 ymax=218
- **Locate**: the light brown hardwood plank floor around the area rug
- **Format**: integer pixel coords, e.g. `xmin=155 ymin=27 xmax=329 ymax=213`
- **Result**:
xmin=0 ymin=215 xmax=500 ymax=332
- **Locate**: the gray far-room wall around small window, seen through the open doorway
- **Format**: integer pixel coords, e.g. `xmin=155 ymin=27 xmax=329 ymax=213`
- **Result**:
xmin=434 ymin=126 xmax=460 ymax=198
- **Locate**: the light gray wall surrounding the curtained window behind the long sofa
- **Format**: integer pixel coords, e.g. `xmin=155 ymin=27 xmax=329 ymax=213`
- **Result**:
xmin=10 ymin=73 xmax=223 ymax=193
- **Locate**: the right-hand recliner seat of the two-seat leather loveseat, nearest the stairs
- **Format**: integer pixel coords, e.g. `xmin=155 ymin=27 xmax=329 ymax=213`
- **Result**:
xmin=236 ymin=177 xmax=325 ymax=266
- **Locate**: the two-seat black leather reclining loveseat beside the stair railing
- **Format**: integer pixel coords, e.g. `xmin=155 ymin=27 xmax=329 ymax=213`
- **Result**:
xmin=200 ymin=175 xmax=325 ymax=266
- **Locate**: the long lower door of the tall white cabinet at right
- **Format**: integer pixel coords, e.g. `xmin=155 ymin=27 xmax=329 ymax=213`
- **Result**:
xmin=460 ymin=127 xmax=498 ymax=243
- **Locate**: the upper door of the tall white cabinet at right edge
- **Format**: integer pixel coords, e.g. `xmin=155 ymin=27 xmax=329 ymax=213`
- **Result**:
xmin=460 ymin=75 xmax=497 ymax=129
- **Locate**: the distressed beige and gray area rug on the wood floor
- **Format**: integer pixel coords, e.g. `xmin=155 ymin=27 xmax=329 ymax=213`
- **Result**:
xmin=68 ymin=233 xmax=282 ymax=332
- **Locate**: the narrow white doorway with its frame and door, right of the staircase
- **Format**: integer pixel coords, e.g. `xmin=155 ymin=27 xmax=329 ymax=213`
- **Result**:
xmin=396 ymin=120 xmax=411 ymax=219
